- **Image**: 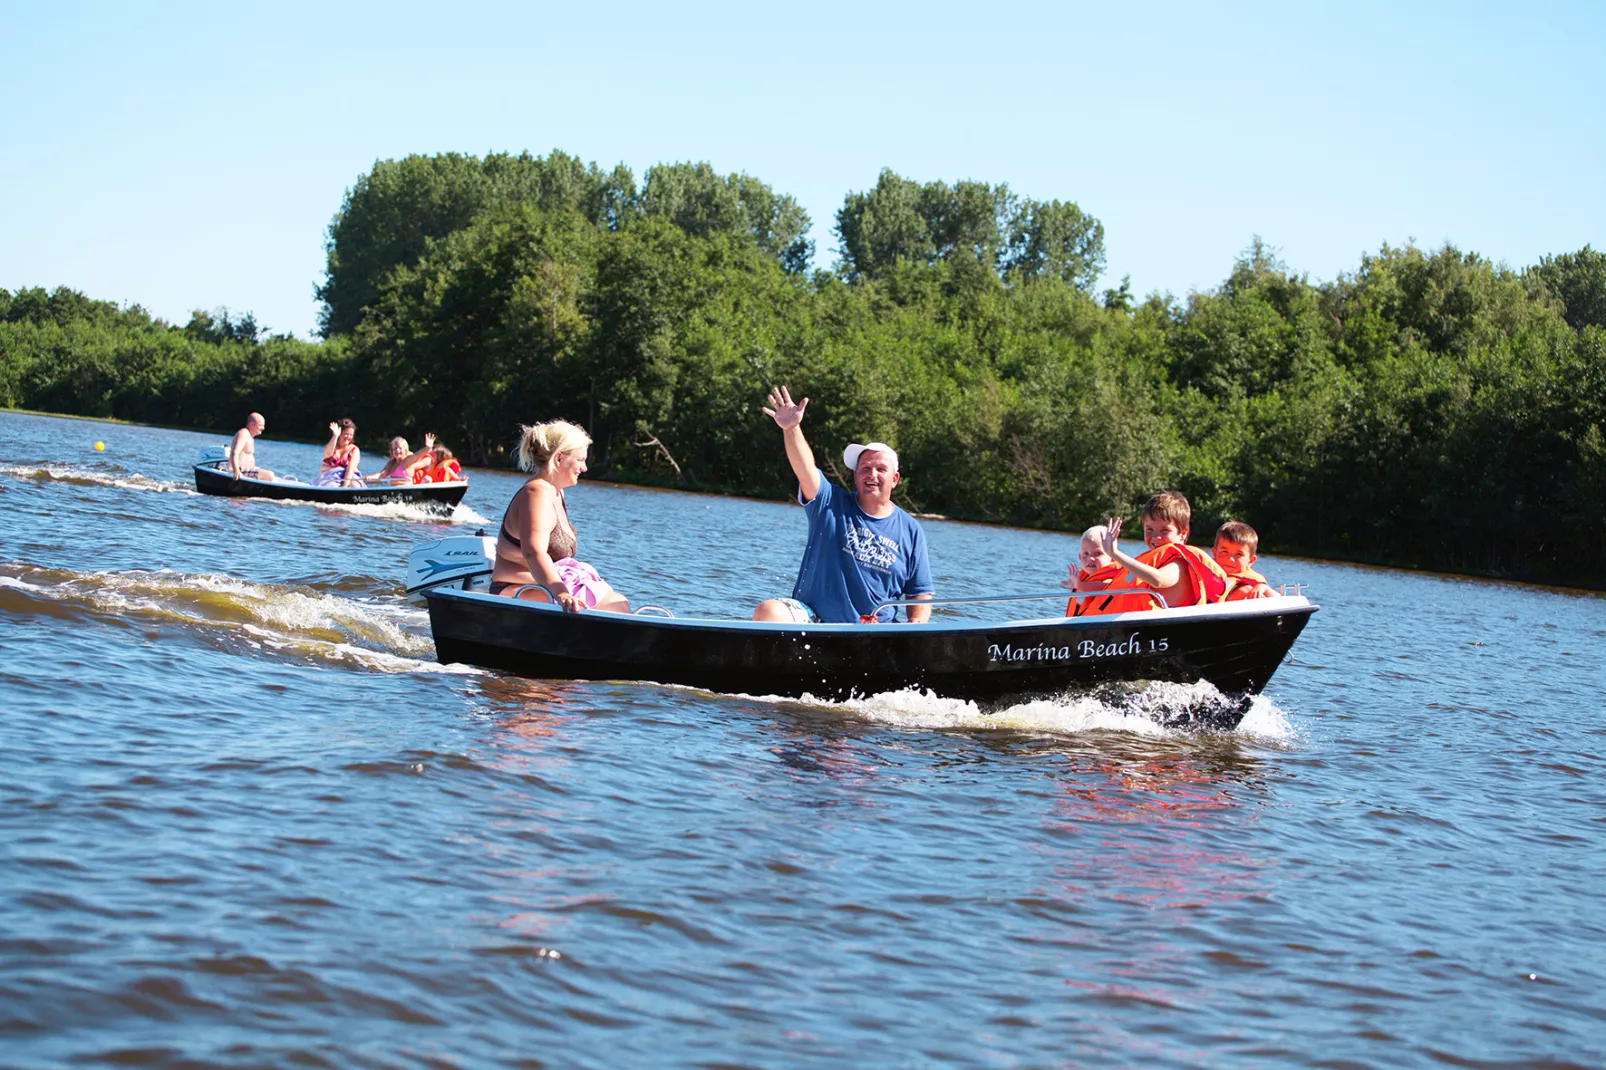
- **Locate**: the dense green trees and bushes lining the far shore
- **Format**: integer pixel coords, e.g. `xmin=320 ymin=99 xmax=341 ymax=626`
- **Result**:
xmin=0 ymin=151 xmax=1606 ymax=588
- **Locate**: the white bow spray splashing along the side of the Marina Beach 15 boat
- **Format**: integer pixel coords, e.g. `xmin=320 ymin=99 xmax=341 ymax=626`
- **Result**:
xmin=803 ymin=681 xmax=1296 ymax=741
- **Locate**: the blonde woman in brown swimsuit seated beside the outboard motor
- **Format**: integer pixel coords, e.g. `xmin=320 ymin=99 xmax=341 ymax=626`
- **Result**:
xmin=491 ymin=419 xmax=630 ymax=614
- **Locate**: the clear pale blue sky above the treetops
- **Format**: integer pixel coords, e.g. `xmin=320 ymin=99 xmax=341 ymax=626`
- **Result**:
xmin=0 ymin=0 xmax=1606 ymax=336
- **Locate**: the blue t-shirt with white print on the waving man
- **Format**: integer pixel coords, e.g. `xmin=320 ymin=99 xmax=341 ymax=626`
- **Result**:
xmin=792 ymin=472 xmax=933 ymax=623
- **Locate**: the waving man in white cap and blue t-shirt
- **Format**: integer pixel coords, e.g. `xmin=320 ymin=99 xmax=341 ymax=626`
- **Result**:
xmin=753 ymin=387 xmax=933 ymax=623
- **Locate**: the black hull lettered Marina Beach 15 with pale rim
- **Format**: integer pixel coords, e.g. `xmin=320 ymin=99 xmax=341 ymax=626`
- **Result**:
xmin=427 ymin=590 xmax=1317 ymax=707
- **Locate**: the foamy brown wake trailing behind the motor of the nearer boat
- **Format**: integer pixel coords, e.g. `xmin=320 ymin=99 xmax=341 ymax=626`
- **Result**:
xmin=0 ymin=562 xmax=479 ymax=673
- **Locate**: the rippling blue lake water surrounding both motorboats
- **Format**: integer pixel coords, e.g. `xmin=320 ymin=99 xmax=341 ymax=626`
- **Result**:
xmin=0 ymin=413 xmax=1606 ymax=1067
